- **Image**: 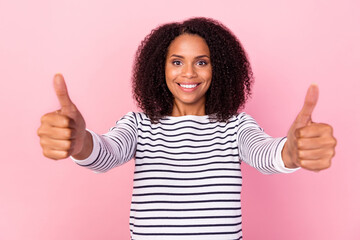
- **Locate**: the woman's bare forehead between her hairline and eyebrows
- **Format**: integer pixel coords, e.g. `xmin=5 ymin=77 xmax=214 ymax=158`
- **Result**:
xmin=168 ymin=34 xmax=210 ymax=56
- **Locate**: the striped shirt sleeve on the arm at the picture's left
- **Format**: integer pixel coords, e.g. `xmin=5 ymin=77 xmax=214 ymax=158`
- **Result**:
xmin=71 ymin=112 xmax=137 ymax=172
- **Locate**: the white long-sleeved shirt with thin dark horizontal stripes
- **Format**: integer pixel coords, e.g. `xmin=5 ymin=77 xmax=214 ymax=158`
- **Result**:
xmin=73 ymin=112 xmax=296 ymax=240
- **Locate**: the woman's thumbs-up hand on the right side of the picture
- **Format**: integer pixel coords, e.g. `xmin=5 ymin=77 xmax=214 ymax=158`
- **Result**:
xmin=282 ymin=85 xmax=336 ymax=171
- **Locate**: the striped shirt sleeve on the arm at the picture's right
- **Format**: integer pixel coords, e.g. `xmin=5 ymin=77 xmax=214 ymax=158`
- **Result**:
xmin=237 ymin=113 xmax=299 ymax=174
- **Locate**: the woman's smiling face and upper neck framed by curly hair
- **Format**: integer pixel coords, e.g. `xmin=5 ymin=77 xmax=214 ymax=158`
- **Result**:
xmin=165 ymin=34 xmax=212 ymax=111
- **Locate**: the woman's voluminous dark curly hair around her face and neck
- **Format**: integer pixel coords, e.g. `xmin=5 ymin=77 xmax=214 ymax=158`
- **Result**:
xmin=132 ymin=17 xmax=253 ymax=123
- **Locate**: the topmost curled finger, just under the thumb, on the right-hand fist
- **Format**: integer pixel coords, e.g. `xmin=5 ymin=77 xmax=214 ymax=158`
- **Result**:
xmin=295 ymin=123 xmax=333 ymax=138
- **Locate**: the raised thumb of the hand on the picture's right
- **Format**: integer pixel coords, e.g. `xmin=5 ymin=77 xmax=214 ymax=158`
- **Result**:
xmin=295 ymin=84 xmax=319 ymax=127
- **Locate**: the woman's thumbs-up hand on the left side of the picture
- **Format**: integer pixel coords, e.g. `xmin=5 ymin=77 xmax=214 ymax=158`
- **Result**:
xmin=37 ymin=74 xmax=87 ymax=160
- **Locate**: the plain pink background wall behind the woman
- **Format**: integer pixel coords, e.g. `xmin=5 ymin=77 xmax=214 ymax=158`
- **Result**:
xmin=0 ymin=0 xmax=360 ymax=240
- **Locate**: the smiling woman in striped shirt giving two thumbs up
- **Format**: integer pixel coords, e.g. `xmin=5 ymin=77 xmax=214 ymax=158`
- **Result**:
xmin=38 ymin=18 xmax=336 ymax=239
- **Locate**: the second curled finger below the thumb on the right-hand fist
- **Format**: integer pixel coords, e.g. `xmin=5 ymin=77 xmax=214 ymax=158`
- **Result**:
xmin=297 ymin=137 xmax=336 ymax=150
